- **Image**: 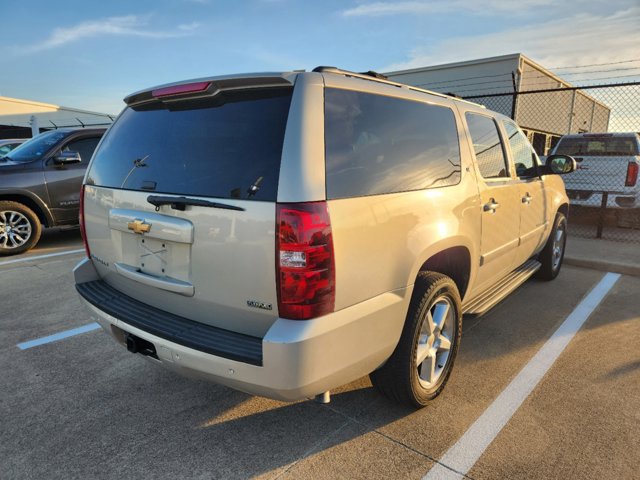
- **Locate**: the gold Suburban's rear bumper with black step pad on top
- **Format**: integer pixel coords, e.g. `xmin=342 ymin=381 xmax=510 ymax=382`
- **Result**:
xmin=74 ymin=259 xmax=412 ymax=401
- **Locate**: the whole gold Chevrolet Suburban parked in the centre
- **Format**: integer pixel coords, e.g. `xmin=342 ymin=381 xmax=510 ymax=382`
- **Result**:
xmin=75 ymin=67 xmax=575 ymax=406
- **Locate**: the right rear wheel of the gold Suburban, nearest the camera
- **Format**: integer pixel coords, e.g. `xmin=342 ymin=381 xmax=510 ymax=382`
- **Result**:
xmin=370 ymin=272 xmax=462 ymax=407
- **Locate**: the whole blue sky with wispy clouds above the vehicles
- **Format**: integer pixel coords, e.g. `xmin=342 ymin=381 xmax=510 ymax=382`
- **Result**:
xmin=0 ymin=0 xmax=640 ymax=114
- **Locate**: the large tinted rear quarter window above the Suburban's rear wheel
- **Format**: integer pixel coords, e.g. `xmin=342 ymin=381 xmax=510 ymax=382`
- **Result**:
xmin=325 ymin=88 xmax=460 ymax=198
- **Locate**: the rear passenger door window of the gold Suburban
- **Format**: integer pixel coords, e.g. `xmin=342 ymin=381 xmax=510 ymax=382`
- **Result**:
xmin=466 ymin=113 xmax=509 ymax=178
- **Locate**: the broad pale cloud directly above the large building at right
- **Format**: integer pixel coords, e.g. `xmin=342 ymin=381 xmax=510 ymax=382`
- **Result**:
xmin=381 ymin=7 xmax=640 ymax=71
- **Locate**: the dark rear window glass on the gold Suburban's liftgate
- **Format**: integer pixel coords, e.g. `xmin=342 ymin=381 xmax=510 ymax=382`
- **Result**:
xmin=87 ymin=88 xmax=292 ymax=201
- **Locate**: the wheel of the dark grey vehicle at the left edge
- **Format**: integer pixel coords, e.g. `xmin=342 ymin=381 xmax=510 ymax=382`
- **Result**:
xmin=0 ymin=202 xmax=42 ymax=255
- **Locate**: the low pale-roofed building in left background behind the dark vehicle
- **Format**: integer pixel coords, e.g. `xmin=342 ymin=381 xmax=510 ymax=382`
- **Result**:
xmin=0 ymin=97 xmax=115 ymax=139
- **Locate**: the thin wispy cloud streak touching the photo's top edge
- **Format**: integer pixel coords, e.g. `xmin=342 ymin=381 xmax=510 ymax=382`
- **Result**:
xmin=342 ymin=0 xmax=558 ymax=17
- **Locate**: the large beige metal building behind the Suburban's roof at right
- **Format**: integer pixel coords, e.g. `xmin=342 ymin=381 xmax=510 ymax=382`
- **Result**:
xmin=385 ymin=53 xmax=611 ymax=155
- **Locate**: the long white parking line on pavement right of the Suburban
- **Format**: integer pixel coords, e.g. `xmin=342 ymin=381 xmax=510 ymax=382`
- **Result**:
xmin=423 ymin=273 xmax=620 ymax=480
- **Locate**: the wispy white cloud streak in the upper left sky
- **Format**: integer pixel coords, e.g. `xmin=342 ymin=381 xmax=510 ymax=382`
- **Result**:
xmin=17 ymin=15 xmax=199 ymax=53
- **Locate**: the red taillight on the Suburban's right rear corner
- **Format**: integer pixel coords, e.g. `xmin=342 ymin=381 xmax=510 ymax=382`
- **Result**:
xmin=276 ymin=202 xmax=335 ymax=320
